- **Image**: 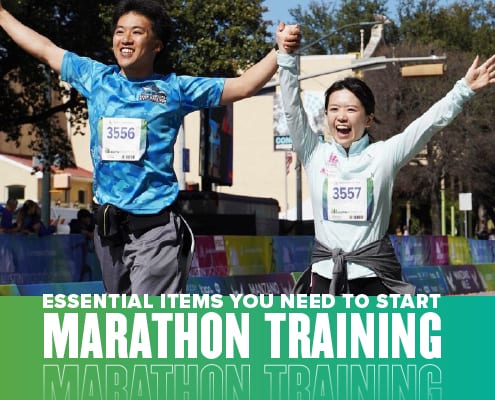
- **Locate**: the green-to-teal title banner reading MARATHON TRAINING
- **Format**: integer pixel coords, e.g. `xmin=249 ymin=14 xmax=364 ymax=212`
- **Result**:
xmin=0 ymin=295 xmax=495 ymax=400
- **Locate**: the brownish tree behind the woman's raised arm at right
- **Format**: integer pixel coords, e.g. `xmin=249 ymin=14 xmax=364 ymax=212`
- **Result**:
xmin=365 ymin=40 xmax=495 ymax=234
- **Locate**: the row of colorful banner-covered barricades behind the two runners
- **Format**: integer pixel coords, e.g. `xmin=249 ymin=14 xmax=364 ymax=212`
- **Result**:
xmin=0 ymin=234 xmax=495 ymax=295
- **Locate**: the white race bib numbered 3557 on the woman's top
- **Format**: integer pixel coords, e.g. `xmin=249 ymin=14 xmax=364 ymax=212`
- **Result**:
xmin=325 ymin=179 xmax=373 ymax=221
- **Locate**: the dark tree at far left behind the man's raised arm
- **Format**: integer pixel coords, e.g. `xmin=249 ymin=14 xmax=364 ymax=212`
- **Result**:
xmin=0 ymin=0 xmax=116 ymax=168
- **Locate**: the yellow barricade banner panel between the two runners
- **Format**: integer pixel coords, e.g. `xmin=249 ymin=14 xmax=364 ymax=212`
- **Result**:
xmin=224 ymin=236 xmax=272 ymax=275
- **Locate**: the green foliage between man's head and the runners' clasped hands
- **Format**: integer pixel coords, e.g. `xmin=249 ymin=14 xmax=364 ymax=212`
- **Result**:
xmin=165 ymin=0 xmax=271 ymax=77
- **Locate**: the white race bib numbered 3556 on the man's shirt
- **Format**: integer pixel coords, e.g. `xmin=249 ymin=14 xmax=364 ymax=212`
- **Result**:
xmin=99 ymin=118 xmax=146 ymax=161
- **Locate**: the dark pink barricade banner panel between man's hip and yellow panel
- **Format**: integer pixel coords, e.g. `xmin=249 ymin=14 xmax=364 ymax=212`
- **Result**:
xmin=190 ymin=235 xmax=228 ymax=276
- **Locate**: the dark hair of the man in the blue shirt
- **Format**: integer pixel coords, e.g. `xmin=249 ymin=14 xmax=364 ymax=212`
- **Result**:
xmin=112 ymin=0 xmax=172 ymax=47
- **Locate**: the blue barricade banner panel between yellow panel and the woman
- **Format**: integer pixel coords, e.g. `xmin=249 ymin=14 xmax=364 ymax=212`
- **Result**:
xmin=272 ymin=236 xmax=314 ymax=272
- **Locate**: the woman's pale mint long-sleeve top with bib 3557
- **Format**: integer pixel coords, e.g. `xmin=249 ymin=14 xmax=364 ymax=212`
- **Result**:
xmin=277 ymin=53 xmax=474 ymax=279
